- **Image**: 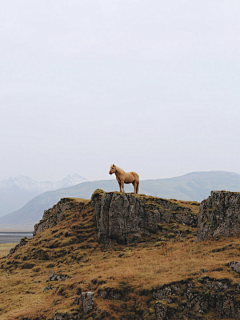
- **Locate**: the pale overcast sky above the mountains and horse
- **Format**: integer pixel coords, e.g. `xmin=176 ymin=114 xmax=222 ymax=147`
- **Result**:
xmin=0 ymin=0 xmax=240 ymax=181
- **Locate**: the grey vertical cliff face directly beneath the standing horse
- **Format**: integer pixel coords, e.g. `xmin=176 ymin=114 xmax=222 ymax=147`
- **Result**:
xmin=91 ymin=190 xmax=197 ymax=247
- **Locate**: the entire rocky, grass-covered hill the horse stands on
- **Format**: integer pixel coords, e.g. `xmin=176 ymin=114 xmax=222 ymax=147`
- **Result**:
xmin=0 ymin=190 xmax=240 ymax=320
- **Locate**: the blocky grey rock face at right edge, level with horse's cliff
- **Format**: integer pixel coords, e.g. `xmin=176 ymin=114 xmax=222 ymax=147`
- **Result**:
xmin=196 ymin=191 xmax=240 ymax=242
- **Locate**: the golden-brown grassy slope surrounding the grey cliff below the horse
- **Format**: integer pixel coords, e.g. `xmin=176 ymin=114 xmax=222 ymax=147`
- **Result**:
xmin=0 ymin=194 xmax=240 ymax=320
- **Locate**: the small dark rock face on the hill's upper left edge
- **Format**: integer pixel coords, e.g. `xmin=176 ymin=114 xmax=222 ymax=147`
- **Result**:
xmin=33 ymin=198 xmax=72 ymax=236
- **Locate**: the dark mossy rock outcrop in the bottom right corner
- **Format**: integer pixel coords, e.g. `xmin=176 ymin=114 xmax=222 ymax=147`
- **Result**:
xmin=153 ymin=277 xmax=240 ymax=320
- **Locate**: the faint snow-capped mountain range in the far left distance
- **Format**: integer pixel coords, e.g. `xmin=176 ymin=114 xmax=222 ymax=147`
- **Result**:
xmin=0 ymin=174 xmax=87 ymax=217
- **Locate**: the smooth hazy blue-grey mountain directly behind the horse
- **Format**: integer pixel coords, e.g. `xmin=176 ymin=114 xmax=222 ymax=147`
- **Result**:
xmin=0 ymin=171 xmax=240 ymax=230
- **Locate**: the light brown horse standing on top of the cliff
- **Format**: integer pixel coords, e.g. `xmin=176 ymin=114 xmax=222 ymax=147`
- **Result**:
xmin=109 ymin=164 xmax=139 ymax=193
